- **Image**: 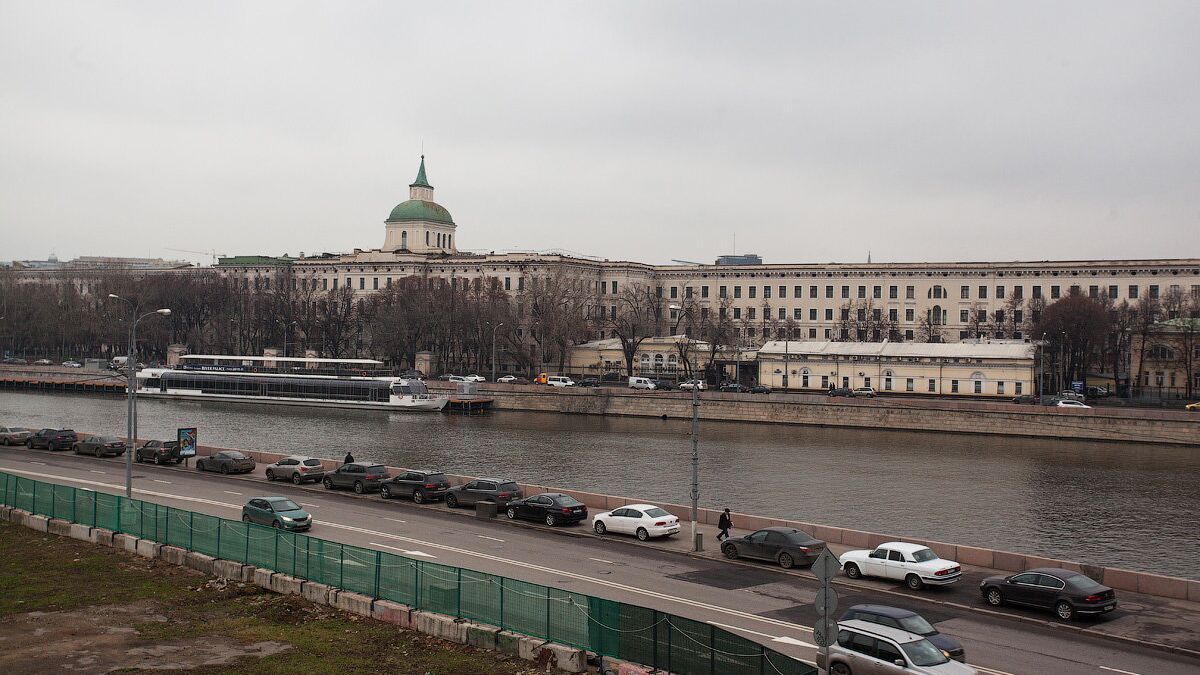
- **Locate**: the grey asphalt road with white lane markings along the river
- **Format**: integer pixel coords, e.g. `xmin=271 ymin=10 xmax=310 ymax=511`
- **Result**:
xmin=0 ymin=448 xmax=1200 ymax=675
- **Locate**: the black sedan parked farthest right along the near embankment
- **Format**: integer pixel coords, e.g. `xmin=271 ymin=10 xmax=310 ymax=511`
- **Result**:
xmin=979 ymin=567 xmax=1117 ymax=621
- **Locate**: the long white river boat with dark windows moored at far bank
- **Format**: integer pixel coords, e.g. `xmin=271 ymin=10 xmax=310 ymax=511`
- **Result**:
xmin=137 ymin=354 xmax=450 ymax=412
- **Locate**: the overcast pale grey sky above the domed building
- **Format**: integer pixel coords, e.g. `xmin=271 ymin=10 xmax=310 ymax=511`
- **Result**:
xmin=0 ymin=0 xmax=1200 ymax=263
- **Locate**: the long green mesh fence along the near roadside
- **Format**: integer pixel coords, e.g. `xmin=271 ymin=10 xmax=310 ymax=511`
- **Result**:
xmin=0 ymin=472 xmax=816 ymax=675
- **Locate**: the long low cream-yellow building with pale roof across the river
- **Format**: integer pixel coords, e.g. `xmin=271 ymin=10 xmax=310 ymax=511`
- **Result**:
xmin=758 ymin=341 xmax=1037 ymax=398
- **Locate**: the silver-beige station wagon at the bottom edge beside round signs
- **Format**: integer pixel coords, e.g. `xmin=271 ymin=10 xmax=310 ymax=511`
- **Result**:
xmin=817 ymin=620 xmax=979 ymax=675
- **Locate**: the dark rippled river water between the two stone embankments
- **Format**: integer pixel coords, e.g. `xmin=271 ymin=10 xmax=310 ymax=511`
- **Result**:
xmin=0 ymin=392 xmax=1200 ymax=579
